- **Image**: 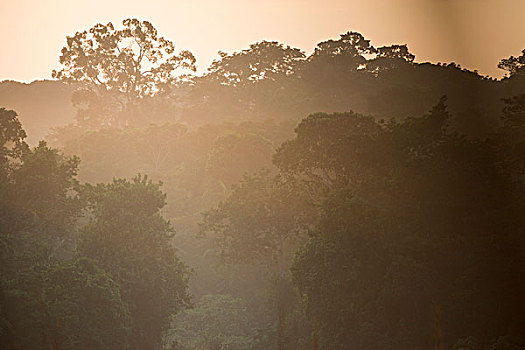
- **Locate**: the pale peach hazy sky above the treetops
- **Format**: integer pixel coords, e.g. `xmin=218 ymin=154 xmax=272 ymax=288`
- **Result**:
xmin=0 ymin=0 xmax=525 ymax=82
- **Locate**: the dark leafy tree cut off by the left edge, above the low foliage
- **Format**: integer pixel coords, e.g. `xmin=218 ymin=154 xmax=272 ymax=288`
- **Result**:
xmin=0 ymin=109 xmax=81 ymax=254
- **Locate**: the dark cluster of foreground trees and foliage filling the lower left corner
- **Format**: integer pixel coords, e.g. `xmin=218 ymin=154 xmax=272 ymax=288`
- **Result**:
xmin=0 ymin=110 xmax=188 ymax=349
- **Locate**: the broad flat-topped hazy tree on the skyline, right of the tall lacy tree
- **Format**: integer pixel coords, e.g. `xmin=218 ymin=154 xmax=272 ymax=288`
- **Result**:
xmin=183 ymin=41 xmax=305 ymax=123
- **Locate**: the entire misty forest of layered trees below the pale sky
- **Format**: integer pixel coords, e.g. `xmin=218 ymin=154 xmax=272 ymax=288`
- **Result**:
xmin=0 ymin=19 xmax=525 ymax=350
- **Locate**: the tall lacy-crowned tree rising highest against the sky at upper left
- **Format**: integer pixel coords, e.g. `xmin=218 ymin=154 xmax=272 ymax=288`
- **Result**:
xmin=52 ymin=19 xmax=195 ymax=127
